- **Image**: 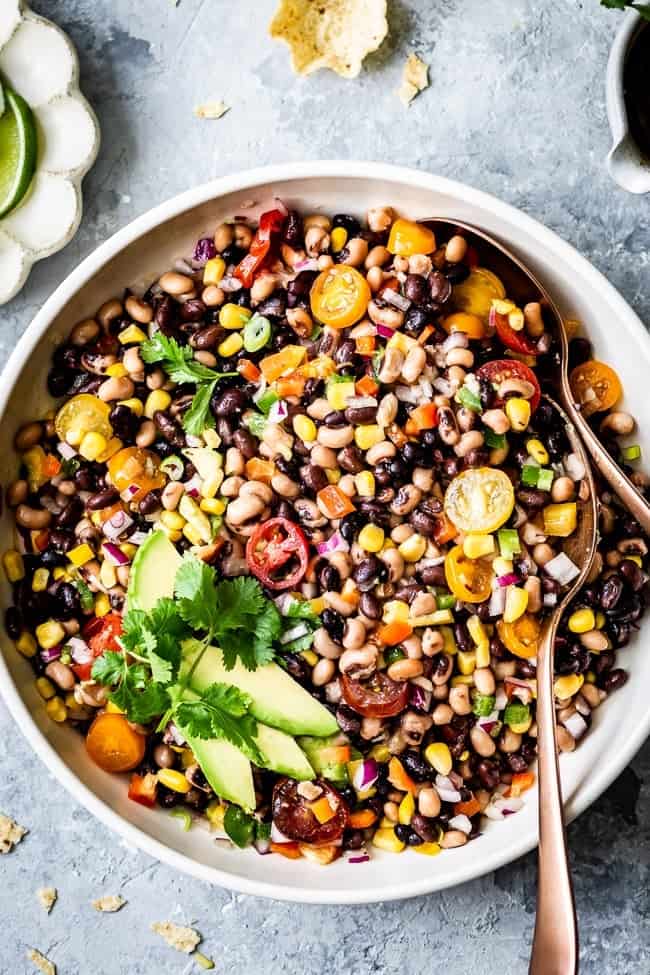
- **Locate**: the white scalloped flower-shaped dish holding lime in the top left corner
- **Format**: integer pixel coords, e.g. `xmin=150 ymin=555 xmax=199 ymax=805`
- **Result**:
xmin=0 ymin=0 xmax=99 ymax=305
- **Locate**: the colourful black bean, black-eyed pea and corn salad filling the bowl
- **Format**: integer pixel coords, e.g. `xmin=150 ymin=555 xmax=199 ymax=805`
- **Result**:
xmin=3 ymin=200 xmax=648 ymax=864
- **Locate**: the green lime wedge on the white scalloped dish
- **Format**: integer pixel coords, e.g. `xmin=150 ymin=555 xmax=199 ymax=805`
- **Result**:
xmin=0 ymin=85 xmax=37 ymax=217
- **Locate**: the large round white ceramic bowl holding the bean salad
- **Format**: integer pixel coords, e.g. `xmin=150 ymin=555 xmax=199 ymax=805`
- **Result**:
xmin=0 ymin=161 xmax=650 ymax=903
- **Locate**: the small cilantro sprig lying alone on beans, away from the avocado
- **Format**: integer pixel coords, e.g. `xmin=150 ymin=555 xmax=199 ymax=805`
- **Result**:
xmin=140 ymin=332 xmax=238 ymax=437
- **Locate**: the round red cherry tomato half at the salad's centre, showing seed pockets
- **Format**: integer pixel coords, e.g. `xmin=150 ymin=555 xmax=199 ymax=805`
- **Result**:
xmin=246 ymin=518 xmax=309 ymax=589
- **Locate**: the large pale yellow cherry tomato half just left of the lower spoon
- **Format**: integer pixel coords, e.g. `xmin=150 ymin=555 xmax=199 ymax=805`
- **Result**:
xmin=445 ymin=467 xmax=515 ymax=533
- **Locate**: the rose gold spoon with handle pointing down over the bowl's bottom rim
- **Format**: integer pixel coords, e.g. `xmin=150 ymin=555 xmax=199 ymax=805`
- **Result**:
xmin=529 ymin=396 xmax=598 ymax=975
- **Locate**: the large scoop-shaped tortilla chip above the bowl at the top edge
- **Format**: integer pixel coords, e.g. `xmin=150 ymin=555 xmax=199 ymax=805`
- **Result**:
xmin=269 ymin=0 xmax=388 ymax=78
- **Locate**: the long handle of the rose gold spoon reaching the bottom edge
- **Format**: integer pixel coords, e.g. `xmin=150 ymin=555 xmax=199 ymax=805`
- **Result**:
xmin=528 ymin=613 xmax=578 ymax=975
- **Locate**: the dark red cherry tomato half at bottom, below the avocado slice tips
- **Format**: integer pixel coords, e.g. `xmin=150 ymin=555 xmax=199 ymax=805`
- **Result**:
xmin=272 ymin=779 xmax=350 ymax=846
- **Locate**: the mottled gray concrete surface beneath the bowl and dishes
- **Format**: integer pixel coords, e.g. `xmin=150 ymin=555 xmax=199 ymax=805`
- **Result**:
xmin=0 ymin=0 xmax=650 ymax=975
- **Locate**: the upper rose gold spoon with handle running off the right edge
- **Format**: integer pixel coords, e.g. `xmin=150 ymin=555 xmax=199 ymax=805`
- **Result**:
xmin=421 ymin=217 xmax=650 ymax=534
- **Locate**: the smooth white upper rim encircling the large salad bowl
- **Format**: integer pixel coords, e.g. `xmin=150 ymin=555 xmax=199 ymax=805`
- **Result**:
xmin=0 ymin=160 xmax=650 ymax=904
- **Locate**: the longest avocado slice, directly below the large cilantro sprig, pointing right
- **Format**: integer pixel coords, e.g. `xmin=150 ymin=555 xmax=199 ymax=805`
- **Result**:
xmin=184 ymin=647 xmax=339 ymax=738
